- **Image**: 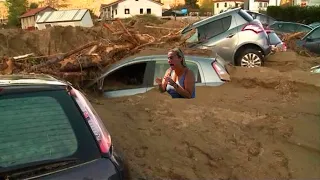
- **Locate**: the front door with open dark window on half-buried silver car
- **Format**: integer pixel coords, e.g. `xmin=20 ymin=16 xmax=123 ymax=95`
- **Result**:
xmin=103 ymin=59 xmax=151 ymax=98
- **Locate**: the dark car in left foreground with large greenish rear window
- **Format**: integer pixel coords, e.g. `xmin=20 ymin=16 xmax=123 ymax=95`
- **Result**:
xmin=0 ymin=74 xmax=124 ymax=180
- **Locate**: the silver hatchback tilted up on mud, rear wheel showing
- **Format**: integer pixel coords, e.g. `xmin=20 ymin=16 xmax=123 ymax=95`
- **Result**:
xmin=181 ymin=8 xmax=271 ymax=67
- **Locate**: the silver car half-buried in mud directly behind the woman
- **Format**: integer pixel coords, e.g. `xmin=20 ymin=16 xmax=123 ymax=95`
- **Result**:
xmin=88 ymin=50 xmax=230 ymax=97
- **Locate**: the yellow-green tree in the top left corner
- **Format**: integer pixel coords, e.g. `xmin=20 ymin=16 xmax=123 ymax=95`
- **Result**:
xmin=6 ymin=0 xmax=28 ymax=26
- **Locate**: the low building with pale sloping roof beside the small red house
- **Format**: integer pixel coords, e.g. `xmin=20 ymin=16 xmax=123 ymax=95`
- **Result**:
xmin=36 ymin=9 xmax=93 ymax=30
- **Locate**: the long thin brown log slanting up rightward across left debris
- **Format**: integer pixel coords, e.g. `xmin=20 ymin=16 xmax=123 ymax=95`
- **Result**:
xmin=30 ymin=41 xmax=99 ymax=71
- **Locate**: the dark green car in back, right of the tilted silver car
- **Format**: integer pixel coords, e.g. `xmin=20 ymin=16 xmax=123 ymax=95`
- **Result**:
xmin=267 ymin=21 xmax=312 ymax=34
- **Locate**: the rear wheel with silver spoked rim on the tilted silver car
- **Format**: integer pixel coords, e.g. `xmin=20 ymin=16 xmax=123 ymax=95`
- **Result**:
xmin=236 ymin=48 xmax=264 ymax=68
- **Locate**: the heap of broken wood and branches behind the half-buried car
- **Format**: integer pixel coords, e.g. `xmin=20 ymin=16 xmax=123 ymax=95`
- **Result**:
xmin=0 ymin=19 xmax=192 ymax=86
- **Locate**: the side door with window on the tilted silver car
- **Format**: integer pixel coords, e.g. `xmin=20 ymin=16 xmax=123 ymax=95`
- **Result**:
xmin=198 ymin=15 xmax=238 ymax=61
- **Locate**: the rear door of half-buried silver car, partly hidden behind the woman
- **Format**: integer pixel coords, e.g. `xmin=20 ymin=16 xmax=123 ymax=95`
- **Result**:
xmin=147 ymin=57 xmax=205 ymax=91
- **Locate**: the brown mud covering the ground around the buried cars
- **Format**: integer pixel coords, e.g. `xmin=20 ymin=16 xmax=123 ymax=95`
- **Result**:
xmin=90 ymin=52 xmax=320 ymax=180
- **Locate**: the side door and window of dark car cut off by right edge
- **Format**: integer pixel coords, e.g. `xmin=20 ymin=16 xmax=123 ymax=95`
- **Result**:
xmin=303 ymin=28 xmax=320 ymax=54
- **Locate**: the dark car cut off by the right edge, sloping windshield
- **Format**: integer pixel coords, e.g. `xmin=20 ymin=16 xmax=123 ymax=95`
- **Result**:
xmin=296 ymin=26 xmax=320 ymax=54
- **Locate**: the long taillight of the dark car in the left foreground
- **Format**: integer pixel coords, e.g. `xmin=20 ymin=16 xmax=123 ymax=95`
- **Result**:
xmin=68 ymin=88 xmax=112 ymax=153
